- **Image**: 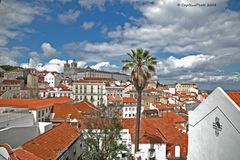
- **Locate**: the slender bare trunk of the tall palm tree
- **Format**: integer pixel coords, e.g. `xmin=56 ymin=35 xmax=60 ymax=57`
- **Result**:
xmin=135 ymin=90 xmax=142 ymax=153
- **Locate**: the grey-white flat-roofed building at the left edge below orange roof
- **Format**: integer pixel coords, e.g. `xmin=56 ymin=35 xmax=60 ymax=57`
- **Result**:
xmin=0 ymin=107 xmax=40 ymax=148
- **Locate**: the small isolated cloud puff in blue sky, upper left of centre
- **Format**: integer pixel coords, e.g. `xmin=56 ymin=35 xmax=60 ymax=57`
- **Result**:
xmin=58 ymin=9 xmax=80 ymax=24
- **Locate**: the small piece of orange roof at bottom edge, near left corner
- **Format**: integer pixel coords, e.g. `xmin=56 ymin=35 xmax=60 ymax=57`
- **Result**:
xmin=14 ymin=149 xmax=43 ymax=160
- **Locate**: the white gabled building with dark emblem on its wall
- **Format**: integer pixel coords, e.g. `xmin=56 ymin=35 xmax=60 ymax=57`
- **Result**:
xmin=188 ymin=87 xmax=240 ymax=160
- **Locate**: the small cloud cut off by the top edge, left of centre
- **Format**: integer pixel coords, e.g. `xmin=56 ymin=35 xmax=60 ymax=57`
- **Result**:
xmin=78 ymin=0 xmax=106 ymax=9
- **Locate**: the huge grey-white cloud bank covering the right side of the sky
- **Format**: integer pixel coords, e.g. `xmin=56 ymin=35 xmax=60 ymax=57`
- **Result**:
xmin=64 ymin=0 xmax=240 ymax=89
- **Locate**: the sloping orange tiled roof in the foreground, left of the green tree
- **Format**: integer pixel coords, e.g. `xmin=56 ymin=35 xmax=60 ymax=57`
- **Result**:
xmin=21 ymin=122 xmax=80 ymax=160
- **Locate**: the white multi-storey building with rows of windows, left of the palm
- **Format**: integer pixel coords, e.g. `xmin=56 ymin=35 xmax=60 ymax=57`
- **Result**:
xmin=72 ymin=80 xmax=107 ymax=106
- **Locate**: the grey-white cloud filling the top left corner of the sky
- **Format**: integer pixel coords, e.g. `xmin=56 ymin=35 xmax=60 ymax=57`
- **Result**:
xmin=0 ymin=0 xmax=47 ymax=46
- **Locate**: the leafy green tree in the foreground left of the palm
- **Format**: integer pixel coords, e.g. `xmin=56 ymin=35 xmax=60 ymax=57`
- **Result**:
xmin=81 ymin=105 xmax=132 ymax=160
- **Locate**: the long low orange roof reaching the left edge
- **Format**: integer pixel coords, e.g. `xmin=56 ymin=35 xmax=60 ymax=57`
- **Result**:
xmin=0 ymin=97 xmax=72 ymax=110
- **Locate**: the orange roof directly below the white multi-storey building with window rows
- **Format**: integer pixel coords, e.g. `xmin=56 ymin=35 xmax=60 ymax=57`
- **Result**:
xmin=52 ymin=101 xmax=99 ymax=120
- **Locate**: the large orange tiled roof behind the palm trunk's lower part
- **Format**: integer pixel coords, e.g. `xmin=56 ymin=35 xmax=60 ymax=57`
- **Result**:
xmin=122 ymin=117 xmax=188 ymax=156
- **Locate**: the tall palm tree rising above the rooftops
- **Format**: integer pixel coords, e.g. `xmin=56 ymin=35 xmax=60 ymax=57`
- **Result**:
xmin=122 ymin=48 xmax=157 ymax=153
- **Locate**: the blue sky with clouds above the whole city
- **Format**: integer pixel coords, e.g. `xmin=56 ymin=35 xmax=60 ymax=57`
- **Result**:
xmin=0 ymin=0 xmax=240 ymax=89
